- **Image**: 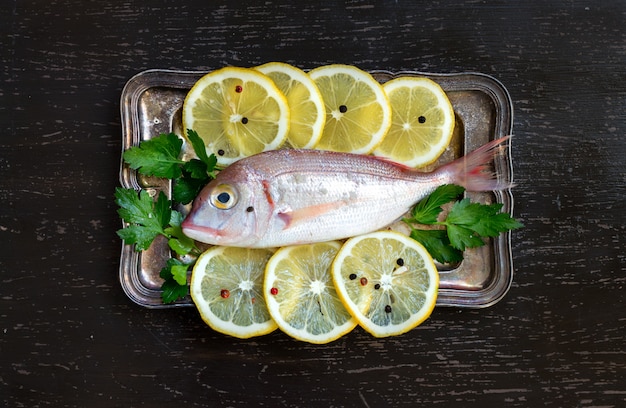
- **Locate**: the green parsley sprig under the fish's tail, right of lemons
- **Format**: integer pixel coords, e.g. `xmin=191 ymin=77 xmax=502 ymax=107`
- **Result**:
xmin=403 ymin=184 xmax=523 ymax=263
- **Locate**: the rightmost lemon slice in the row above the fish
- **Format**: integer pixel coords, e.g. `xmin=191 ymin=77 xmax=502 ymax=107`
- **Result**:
xmin=374 ymin=77 xmax=455 ymax=167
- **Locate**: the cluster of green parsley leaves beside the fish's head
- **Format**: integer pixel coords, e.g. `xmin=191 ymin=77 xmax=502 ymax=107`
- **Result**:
xmin=115 ymin=130 xmax=217 ymax=303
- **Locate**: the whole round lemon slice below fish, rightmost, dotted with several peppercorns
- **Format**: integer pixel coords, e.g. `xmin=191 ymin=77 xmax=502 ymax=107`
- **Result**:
xmin=332 ymin=231 xmax=439 ymax=337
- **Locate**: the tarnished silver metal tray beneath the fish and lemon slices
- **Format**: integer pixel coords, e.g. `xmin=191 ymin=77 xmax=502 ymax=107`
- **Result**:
xmin=119 ymin=70 xmax=513 ymax=308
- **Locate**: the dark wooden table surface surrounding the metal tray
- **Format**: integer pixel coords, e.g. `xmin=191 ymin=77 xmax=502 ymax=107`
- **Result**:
xmin=0 ymin=0 xmax=626 ymax=407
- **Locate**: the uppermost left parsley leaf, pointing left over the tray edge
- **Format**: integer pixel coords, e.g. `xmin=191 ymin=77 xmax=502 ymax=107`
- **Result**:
xmin=123 ymin=133 xmax=184 ymax=179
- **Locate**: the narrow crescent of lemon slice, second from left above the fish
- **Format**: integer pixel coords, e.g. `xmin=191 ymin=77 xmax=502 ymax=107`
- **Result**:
xmin=256 ymin=62 xmax=326 ymax=149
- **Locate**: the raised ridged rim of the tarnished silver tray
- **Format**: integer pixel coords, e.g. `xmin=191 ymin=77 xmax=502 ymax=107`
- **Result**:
xmin=119 ymin=68 xmax=514 ymax=309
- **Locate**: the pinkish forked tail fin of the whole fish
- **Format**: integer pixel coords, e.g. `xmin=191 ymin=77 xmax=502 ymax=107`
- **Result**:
xmin=444 ymin=136 xmax=513 ymax=191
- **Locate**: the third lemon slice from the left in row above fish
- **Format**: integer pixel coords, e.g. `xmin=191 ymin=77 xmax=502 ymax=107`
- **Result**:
xmin=309 ymin=64 xmax=391 ymax=154
